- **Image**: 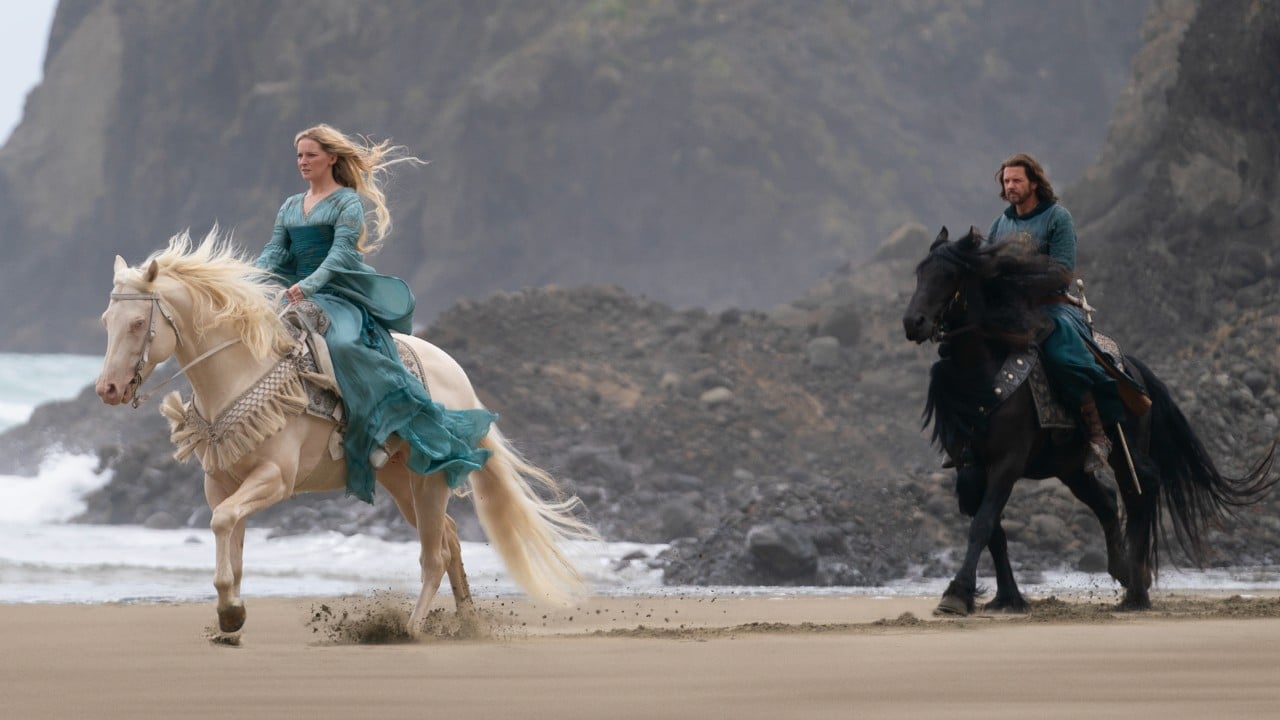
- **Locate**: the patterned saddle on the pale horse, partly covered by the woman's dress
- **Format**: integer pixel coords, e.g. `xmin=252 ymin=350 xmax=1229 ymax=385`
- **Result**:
xmin=280 ymin=300 xmax=430 ymax=460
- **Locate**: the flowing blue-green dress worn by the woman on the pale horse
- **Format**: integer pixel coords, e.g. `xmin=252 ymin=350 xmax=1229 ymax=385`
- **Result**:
xmin=257 ymin=187 xmax=497 ymax=502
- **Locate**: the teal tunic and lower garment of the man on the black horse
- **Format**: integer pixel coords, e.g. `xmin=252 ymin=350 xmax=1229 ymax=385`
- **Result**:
xmin=987 ymin=202 xmax=1124 ymax=425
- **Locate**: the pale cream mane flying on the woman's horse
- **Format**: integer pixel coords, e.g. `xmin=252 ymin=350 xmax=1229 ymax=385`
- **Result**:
xmin=115 ymin=225 xmax=293 ymax=359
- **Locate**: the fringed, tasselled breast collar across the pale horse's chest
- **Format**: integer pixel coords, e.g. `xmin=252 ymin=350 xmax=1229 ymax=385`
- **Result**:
xmin=160 ymin=346 xmax=307 ymax=471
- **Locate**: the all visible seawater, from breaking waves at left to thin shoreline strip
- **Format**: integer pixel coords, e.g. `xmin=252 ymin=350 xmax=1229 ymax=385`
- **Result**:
xmin=0 ymin=354 xmax=1280 ymax=603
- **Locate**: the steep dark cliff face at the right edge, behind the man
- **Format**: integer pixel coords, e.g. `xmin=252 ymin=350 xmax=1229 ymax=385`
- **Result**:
xmin=1071 ymin=0 xmax=1280 ymax=356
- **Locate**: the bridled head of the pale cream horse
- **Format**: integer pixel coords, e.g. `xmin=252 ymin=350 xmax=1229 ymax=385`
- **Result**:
xmin=95 ymin=255 xmax=189 ymax=405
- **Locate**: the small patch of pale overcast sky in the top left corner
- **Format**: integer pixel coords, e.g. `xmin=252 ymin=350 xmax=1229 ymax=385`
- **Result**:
xmin=0 ymin=0 xmax=58 ymax=141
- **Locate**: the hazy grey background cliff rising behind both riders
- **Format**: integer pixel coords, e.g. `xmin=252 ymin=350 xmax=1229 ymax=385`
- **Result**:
xmin=0 ymin=0 xmax=1149 ymax=352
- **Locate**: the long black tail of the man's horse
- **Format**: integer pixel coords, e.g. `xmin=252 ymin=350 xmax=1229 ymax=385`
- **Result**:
xmin=1125 ymin=356 xmax=1280 ymax=569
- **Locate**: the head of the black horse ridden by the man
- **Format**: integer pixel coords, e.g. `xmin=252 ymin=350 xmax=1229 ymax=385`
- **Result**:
xmin=902 ymin=227 xmax=983 ymax=342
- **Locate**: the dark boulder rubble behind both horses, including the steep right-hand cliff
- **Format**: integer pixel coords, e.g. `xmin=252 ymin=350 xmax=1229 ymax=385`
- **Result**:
xmin=0 ymin=0 xmax=1280 ymax=584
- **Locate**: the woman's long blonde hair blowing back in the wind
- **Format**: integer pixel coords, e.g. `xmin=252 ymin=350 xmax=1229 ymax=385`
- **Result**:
xmin=293 ymin=123 xmax=424 ymax=252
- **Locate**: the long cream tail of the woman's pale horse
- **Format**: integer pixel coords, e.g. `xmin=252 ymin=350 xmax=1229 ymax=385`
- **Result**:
xmin=471 ymin=425 xmax=600 ymax=605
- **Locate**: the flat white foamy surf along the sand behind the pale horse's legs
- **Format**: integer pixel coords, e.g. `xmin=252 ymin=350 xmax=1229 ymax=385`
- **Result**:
xmin=0 ymin=523 xmax=666 ymax=603
